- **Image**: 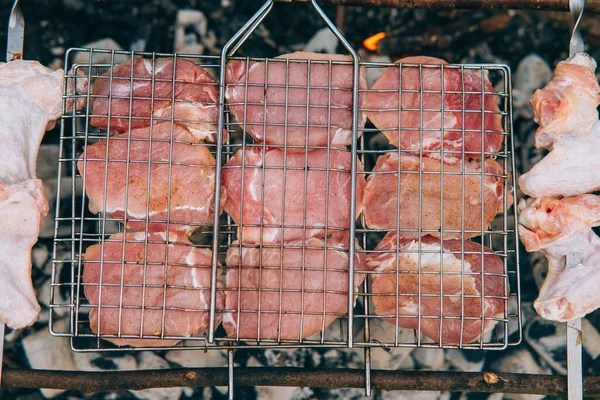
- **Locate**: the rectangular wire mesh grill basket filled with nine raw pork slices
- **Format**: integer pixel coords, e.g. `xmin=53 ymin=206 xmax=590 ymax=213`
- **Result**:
xmin=50 ymin=49 xmax=520 ymax=351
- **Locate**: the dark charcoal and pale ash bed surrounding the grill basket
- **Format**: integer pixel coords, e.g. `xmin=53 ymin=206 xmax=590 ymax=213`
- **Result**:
xmin=0 ymin=0 xmax=600 ymax=400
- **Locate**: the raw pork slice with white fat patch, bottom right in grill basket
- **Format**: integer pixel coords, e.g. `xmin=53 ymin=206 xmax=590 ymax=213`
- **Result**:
xmin=367 ymin=232 xmax=508 ymax=344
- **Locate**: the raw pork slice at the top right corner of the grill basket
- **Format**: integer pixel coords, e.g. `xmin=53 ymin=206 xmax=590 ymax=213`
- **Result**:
xmin=364 ymin=56 xmax=504 ymax=163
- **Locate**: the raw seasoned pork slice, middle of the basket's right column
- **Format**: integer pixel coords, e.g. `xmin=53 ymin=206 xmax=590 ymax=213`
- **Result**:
xmin=363 ymin=152 xmax=512 ymax=239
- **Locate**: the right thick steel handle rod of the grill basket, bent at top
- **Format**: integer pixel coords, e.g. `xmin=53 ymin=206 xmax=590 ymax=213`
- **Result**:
xmin=311 ymin=0 xmax=360 ymax=348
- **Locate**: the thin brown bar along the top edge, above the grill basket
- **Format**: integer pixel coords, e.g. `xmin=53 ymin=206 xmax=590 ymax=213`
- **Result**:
xmin=276 ymin=0 xmax=600 ymax=13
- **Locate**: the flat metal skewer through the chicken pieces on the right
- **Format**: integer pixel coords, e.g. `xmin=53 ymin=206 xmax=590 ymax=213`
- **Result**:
xmin=565 ymin=0 xmax=585 ymax=400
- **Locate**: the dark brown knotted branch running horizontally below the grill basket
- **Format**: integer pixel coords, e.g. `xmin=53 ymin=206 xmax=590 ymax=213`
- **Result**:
xmin=2 ymin=367 xmax=600 ymax=397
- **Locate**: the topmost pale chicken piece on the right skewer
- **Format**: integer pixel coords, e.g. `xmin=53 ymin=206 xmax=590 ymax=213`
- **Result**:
xmin=531 ymin=53 xmax=600 ymax=149
